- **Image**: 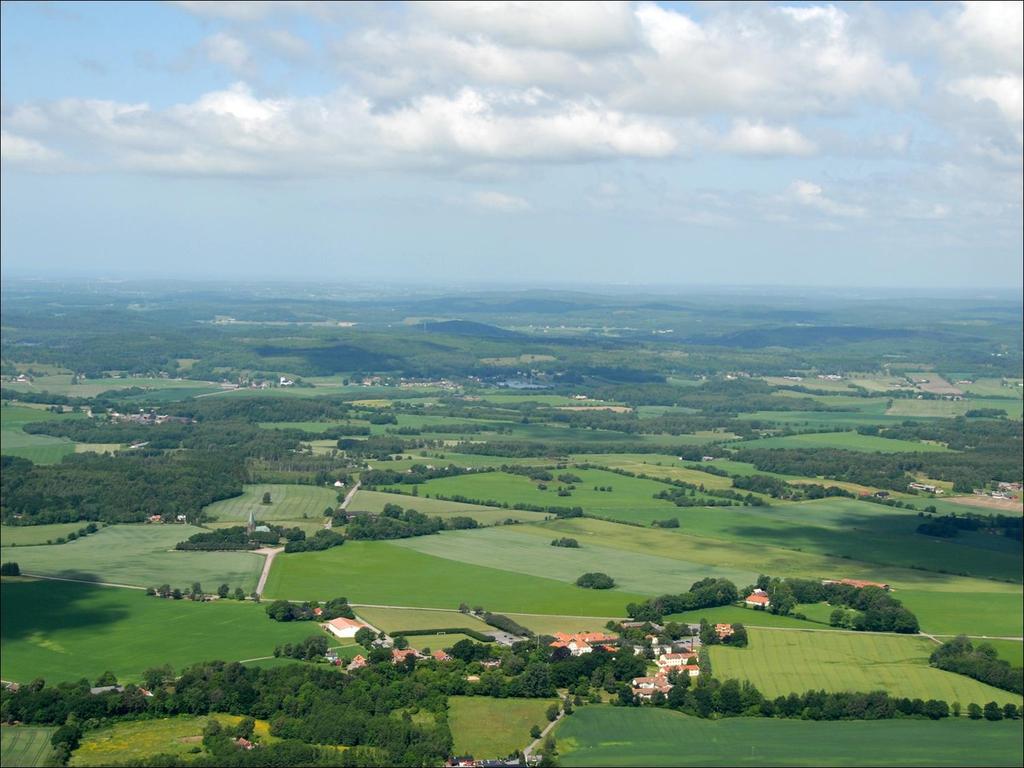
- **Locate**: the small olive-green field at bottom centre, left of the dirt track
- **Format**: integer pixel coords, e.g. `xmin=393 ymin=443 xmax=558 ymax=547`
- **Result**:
xmin=449 ymin=696 xmax=555 ymax=760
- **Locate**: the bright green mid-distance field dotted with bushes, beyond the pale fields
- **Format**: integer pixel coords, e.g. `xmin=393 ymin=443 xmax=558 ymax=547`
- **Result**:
xmin=407 ymin=469 xmax=696 ymax=523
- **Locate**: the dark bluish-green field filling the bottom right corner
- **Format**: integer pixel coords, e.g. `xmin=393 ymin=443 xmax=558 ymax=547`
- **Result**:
xmin=555 ymin=706 xmax=1022 ymax=766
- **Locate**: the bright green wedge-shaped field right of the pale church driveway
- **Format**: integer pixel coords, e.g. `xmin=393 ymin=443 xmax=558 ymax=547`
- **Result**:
xmin=264 ymin=542 xmax=640 ymax=615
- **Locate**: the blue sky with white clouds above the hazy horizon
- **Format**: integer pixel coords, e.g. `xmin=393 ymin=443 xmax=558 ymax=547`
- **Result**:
xmin=0 ymin=2 xmax=1024 ymax=290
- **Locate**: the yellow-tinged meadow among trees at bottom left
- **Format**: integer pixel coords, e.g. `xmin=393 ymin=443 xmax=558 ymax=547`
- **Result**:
xmin=69 ymin=715 xmax=278 ymax=766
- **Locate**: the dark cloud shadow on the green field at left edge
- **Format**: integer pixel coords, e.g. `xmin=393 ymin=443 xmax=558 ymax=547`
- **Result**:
xmin=0 ymin=571 xmax=130 ymax=641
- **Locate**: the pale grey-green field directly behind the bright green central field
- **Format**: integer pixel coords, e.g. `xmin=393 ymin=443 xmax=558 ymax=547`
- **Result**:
xmin=387 ymin=525 xmax=758 ymax=596
